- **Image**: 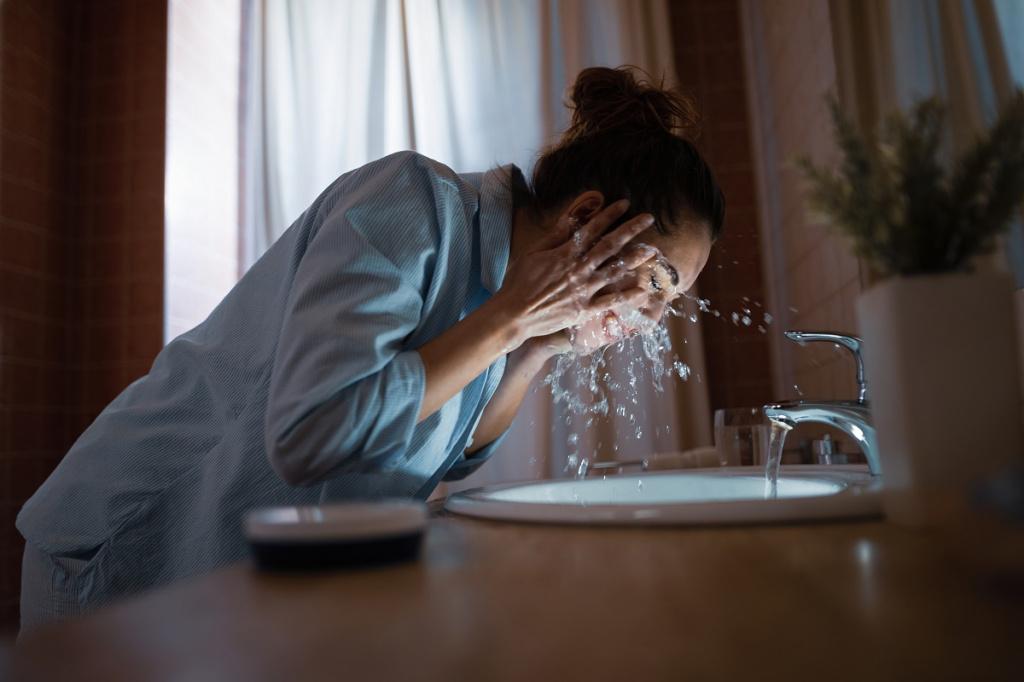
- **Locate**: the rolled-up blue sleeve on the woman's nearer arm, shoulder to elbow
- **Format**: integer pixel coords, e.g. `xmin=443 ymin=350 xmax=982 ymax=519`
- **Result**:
xmin=265 ymin=155 xmax=437 ymax=485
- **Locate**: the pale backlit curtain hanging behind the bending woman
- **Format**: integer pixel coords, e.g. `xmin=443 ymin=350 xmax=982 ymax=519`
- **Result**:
xmin=242 ymin=0 xmax=710 ymax=484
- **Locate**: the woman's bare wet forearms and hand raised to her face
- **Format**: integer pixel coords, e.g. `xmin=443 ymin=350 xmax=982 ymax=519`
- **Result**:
xmin=418 ymin=196 xmax=657 ymax=421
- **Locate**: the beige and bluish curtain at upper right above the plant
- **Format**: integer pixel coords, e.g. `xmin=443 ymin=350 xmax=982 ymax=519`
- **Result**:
xmin=830 ymin=0 xmax=1024 ymax=288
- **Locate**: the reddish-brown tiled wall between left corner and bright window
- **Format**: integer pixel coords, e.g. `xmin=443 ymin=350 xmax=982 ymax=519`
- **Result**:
xmin=70 ymin=0 xmax=167 ymax=419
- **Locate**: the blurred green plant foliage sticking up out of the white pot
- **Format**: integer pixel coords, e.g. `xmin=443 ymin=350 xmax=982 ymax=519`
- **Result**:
xmin=798 ymin=90 xmax=1024 ymax=276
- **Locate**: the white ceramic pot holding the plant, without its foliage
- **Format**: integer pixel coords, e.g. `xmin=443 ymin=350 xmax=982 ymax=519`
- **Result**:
xmin=857 ymin=272 xmax=1024 ymax=526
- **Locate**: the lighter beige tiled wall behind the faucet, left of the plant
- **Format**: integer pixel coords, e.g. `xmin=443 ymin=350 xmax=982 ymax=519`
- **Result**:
xmin=741 ymin=0 xmax=860 ymax=398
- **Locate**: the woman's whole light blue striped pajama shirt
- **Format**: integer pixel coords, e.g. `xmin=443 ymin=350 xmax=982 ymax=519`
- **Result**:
xmin=17 ymin=152 xmax=519 ymax=605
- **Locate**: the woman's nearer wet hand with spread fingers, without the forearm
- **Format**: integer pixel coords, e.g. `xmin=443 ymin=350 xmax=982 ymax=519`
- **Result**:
xmin=493 ymin=195 xmax=657 ymax=347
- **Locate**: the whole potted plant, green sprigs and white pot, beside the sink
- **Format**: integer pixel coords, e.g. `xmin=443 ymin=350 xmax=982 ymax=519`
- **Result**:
xmin=800 ymin=91 xmax=1024 ymax=525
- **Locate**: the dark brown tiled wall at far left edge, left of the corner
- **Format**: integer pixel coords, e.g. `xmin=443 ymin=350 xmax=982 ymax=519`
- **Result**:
xmin=0 ymin=2 xmax=66 ymax=625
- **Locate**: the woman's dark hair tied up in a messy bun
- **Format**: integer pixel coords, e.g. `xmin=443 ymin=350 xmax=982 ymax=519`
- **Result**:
xmin=513 ymin=67 xmax=725 ymax=241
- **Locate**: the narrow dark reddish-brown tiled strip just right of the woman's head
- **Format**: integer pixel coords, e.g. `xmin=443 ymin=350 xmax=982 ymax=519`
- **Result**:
xmin=669 ymin=0 xmax=777 ymax=410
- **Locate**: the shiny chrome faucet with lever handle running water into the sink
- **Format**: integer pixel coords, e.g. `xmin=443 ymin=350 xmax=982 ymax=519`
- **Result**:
xmin=764 ymin=331 xmax=882 ymax=476
